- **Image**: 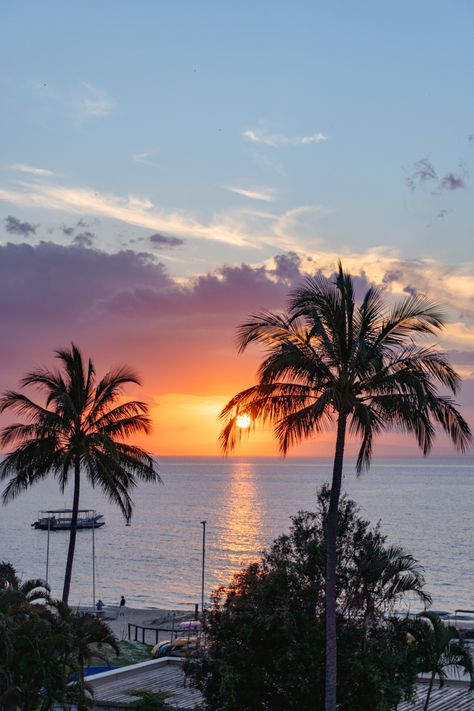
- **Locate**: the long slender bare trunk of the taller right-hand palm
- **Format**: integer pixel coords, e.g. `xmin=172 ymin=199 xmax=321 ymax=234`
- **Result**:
xmin=324 ymin=413 xmax=347 ymax=711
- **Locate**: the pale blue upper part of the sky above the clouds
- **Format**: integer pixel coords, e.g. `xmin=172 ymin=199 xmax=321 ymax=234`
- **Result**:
xmin=0 ymin=1 xmax=474 ymax=266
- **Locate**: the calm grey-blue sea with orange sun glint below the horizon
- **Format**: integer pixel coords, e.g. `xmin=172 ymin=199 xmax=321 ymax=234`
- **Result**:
xmin=0 ymin=458 xmax=474 ymax=610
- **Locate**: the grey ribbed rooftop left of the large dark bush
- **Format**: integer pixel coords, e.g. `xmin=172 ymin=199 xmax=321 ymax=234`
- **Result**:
xmin=87 ymin=657 xmax=202 ymax=711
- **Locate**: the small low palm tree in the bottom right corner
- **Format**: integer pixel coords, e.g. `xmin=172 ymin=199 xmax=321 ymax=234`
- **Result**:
xmin=406 ymin=612 xmax=474 ymax=711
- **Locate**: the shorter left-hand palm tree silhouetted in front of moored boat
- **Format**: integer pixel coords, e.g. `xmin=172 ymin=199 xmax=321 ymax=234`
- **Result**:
xmin=0 ymin=344 xmax=161 ymax=603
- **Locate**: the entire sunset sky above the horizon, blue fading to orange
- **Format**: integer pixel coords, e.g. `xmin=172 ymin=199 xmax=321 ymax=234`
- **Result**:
xmin=0 ymin=0 xmax=474 ymax=456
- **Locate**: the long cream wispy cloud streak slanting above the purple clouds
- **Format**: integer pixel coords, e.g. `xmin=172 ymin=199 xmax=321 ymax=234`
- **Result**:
xmin=0 ymin=183 xmax=259 ymax=248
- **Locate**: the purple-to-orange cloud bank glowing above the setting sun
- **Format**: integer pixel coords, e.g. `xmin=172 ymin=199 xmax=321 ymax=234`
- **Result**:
xmin=0 ymin=239 xmax=474 ymax=450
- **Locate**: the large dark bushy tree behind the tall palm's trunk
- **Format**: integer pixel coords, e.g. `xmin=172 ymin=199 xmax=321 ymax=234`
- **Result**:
xmin=188 ymin=486 xmax=429 ymax=711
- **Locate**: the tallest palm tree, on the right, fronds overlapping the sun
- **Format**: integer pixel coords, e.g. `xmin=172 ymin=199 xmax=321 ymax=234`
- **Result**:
xmin=220 ymin=264 xmax=471 ymax=711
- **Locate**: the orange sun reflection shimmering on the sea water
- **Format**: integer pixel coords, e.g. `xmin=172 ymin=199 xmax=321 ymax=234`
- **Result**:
xmin=215 ymin=462 xmax=264 ymax=584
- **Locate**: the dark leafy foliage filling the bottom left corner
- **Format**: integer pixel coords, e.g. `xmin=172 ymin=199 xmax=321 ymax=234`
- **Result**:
xmin=0 ymin=563 xmax=118 ymax=711
